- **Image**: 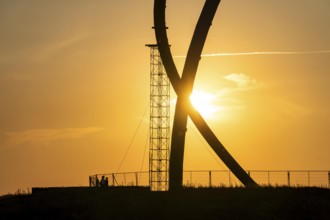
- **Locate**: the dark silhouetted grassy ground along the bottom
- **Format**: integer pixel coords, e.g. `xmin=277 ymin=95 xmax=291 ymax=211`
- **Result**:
xmin=0 ymin=187 xmax=330 ymax=220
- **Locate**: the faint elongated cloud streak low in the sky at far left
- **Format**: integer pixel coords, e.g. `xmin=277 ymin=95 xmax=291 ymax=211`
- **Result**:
xmin=5 ymin=127 xmax=104 ymax=146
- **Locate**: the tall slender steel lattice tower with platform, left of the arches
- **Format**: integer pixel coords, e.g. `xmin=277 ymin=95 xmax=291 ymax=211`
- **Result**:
xmin=146 ymin=44 xmax=170 ymax=191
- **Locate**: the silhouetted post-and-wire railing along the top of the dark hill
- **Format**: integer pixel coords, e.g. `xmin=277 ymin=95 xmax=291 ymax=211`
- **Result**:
xmin=89 ymin=170 xmax=330 ymax=188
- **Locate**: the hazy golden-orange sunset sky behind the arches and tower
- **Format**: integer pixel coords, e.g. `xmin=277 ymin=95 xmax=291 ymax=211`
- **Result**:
xmin=0 ymin=0 xmax=330 ymax=194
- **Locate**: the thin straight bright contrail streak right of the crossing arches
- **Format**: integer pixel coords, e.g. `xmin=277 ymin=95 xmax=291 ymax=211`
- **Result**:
xmin=175 ymin=50 xmax=330 ymax=58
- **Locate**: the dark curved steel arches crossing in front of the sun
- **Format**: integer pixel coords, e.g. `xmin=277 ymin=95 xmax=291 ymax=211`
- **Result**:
xmin=154 ymin=0 xmax=258 ymax=190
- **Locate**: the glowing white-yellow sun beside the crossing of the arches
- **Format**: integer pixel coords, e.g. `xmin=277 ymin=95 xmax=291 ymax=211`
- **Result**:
xmin=190 ymin=91 xmax=219 ymax=117
